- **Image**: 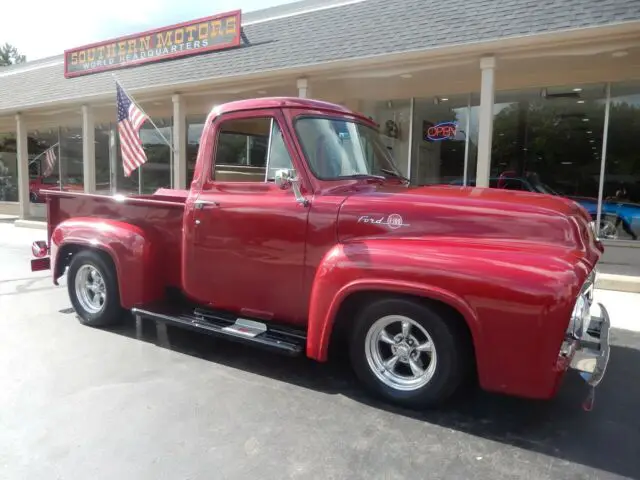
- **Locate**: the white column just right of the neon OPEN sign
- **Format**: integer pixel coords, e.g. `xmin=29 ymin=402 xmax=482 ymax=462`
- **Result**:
xmin=476 ymin=57 xmax=496 ymax=187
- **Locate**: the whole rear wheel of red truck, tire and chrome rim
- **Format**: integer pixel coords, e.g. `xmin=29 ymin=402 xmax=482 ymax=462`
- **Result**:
xmin=67 ymin=250 xmax=123 ymax=327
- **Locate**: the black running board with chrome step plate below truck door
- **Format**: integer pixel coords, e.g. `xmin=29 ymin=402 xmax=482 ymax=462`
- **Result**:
xmin=131 ymin=304 xmax=307 ymax=356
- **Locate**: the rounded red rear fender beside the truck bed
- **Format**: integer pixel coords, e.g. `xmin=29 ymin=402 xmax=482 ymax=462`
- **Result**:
xmin=51 ymin=217 xmax=163 ymax=308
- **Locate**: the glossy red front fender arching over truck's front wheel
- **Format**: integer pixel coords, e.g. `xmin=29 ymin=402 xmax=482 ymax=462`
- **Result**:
xmin=307 ymin=238 xmax=590 ymax=397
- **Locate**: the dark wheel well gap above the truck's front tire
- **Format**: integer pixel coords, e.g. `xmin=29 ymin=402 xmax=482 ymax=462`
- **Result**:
xmin=329 ymin=290 xmax=476 ymax=370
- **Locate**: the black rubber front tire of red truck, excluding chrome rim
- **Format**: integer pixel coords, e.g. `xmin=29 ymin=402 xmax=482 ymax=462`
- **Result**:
xmin=350 ymin=298 xmax=471 ymax=409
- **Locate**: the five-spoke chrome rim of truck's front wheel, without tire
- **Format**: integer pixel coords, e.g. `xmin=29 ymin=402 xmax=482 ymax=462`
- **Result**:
xmin=365 ymin=315 xmax=438 ymax=391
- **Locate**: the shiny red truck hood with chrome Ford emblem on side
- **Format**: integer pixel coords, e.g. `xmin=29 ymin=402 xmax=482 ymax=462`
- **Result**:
xmin=338 ymin=185 xmax=602 ymax=263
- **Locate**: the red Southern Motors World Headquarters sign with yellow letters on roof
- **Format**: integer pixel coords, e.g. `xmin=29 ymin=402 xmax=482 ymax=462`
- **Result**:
xmin=64 ymin=11 xmax=241 ymax=78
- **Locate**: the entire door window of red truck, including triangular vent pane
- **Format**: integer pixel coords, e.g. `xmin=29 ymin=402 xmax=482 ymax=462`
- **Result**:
xmin=213 ymin=117 xmax=293 ymax=182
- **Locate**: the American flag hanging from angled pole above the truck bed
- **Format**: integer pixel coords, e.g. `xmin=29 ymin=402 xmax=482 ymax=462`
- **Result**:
xmin=116 ymin=82 xmax=149 ymax=177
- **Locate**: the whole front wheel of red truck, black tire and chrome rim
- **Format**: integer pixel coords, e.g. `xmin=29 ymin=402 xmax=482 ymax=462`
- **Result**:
xmin=350 ymin=298 xmax=469 ymax=408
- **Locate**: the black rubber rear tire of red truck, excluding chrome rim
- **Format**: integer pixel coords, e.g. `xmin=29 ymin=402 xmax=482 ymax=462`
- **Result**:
xmin=67 ymin=250 xmax=124 ymax=327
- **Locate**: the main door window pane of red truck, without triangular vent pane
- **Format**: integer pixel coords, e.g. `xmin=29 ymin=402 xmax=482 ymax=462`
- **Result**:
xmin=213 ymin=117 xmax=272 ymax=182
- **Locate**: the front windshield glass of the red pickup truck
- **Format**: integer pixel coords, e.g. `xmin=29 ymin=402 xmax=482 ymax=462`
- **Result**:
xmin=295 ymin=117 xmax=402 ymax=180
